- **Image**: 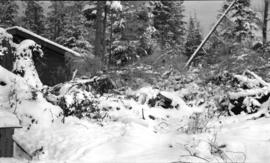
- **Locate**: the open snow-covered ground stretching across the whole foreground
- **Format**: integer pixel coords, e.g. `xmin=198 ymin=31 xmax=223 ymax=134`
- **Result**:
xmin=0 ymin=84 xmax=270 ymax=163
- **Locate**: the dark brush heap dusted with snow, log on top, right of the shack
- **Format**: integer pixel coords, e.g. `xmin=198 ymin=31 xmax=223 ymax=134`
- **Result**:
xmin=45 ymin=75 xmax=114 ymax=119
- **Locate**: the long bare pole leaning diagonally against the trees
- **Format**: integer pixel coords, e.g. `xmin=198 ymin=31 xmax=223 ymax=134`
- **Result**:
xmin=185 ymin=0 xmax=237 ymax=68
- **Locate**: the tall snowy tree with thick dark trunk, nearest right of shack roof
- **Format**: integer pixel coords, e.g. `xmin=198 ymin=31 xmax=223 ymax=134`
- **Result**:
xmin=83 ymin=1 xmax=123 ymax=62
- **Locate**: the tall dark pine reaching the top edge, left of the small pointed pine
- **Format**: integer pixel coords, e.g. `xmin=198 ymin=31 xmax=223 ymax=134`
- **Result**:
xmin=153 ymin=1 xmax=185 ymax=50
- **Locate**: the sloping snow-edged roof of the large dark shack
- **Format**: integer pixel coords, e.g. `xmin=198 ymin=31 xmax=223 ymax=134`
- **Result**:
xmin=6 ymin=26 xmax=82 ymax=57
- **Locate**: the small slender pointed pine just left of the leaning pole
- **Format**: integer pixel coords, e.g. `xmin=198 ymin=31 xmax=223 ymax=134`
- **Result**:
xmin=185 ymin=17 xmax=202 ymax=57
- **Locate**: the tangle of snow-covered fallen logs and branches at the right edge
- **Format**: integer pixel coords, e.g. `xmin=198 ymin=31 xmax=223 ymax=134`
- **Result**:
xmin=228 ymin=70 xmax=270 ymax=115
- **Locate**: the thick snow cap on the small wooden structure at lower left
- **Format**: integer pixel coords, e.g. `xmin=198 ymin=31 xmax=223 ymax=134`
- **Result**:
xmin=0 ymin=110 xmax=20 ymax=128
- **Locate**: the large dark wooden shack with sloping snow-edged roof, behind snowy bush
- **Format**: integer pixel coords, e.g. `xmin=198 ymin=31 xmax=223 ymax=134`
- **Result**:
xmin=4 ymin=26 xmax=81 ymax=86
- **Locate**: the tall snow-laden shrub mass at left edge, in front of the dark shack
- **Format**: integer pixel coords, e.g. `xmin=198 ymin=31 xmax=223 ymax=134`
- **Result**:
xmin=0 ymin=29 xmax=62 ymax=129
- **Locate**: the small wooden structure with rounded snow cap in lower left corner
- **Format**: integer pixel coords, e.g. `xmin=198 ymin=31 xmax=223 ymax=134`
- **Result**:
xmin=0 ymin=110 xmax=20 ymax=157
